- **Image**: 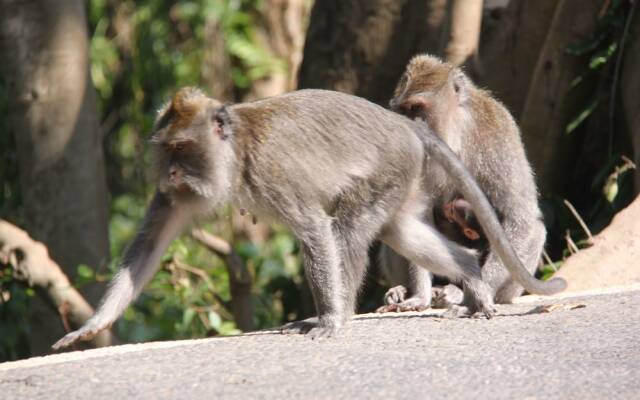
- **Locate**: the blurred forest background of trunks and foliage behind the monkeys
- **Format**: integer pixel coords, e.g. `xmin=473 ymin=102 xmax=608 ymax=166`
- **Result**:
xmin=0 ymin=0 xmax=640 ymax=362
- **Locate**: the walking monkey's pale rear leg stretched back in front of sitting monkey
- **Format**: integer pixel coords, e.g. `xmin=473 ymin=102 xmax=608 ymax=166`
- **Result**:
xmin=382 ymin=213 xmax=495 ymax=318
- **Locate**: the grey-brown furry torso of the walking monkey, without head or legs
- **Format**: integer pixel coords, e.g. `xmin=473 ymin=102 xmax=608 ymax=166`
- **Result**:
xmin=229 ymin=90 xmax=423 ymax=216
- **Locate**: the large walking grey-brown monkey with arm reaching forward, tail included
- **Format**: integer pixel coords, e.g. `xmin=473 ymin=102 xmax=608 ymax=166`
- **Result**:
xmin=53 ymin=88 xmax=564 ymax=348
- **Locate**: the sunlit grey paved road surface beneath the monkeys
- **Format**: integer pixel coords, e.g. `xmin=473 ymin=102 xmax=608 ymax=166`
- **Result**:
xmin=0 ymin=290 xmax=640 ymax=400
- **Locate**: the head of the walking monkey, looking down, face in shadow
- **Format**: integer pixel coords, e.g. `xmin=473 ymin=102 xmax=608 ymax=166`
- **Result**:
xmin=151 ymin=88 xmax=233 ymax=200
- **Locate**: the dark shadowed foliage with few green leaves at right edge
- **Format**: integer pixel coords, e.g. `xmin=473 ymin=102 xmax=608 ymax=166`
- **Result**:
xmin=542 ymin=0 xmax=635 ymax=276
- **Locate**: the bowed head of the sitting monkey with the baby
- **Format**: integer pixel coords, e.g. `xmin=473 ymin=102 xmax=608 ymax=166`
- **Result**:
xmin=389 ymin=55 xmax=470 ymax=131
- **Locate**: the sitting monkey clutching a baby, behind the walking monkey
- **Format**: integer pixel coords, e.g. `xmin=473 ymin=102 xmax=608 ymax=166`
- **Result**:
xmin=383 ymin=55 xmax=546 ymax=309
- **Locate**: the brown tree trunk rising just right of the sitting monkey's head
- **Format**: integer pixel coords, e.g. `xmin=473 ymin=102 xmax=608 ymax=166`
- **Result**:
xmin=478 ymin=0 xmax=558 ymax=119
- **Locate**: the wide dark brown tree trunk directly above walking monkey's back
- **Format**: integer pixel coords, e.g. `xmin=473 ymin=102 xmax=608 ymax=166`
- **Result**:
xmin=298 ymin=0 xmax=446 ymax=105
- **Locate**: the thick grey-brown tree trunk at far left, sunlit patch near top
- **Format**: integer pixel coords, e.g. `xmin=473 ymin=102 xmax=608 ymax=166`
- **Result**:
xmin=0 ymin=0 xmax=109 ymax=355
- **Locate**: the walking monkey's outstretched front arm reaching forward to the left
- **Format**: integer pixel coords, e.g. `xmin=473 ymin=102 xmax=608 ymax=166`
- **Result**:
xmin=52 ymin=192 xmax=187 ymax=350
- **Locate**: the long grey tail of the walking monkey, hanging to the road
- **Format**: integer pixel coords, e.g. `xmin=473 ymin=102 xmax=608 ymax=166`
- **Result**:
xmin=418 ymin=123 xmax=567 ymax=295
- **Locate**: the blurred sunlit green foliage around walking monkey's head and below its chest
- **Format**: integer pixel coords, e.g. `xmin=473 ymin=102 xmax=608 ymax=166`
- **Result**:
xmin=85 ymin=0 xmax=300 ymax=341
